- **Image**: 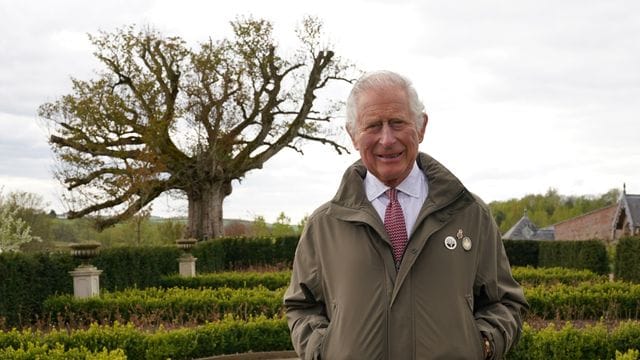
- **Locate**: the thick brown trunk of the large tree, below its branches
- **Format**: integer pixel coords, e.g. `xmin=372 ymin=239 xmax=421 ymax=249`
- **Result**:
xmin=185 ymin=182 xmax=231 ymax=241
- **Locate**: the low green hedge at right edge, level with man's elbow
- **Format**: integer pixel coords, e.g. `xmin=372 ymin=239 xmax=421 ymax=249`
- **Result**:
xmin=524 ymin=282 xmax=640 ymax=320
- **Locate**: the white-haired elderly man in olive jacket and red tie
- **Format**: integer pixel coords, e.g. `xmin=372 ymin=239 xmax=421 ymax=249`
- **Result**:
xmin=284 ymin=71 xmax=528 ymax=360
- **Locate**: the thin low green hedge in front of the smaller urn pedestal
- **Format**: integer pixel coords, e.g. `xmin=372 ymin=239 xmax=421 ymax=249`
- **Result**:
xmin=160 ymin=270 xmax=291 ymax=290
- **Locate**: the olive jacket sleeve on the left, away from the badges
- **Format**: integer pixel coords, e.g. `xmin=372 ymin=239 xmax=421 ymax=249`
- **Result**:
xmin=284 ymin=228 xmax=329 ymax=360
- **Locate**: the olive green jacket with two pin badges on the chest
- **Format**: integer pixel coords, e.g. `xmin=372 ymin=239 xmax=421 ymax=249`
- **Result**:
xmin=284 ymin=153 xmax=528 ymax=360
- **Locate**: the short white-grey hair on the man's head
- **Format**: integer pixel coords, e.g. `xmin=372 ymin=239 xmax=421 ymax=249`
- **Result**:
xmin=345 ymin=70 xmax=424 ymax=134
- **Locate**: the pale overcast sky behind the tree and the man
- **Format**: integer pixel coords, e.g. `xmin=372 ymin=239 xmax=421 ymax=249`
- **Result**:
xmin=0 ymin=0 xmax=640 ymax=223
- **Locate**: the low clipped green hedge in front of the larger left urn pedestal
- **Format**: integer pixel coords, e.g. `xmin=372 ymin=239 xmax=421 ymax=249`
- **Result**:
xmin=44 ymin=286 xmax=284 ymax=328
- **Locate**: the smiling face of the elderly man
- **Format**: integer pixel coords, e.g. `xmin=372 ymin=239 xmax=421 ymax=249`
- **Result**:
xmin=350 ymin=87 xmax=427 ymax=187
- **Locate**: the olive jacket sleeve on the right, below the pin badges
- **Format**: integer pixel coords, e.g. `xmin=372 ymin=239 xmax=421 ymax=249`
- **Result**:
xmin=474 ymin=209 xmax=529 ymax=359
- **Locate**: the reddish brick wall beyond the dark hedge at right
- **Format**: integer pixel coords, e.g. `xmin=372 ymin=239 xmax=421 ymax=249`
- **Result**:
xmin=554 ymin=204 xmax=618 ymax=241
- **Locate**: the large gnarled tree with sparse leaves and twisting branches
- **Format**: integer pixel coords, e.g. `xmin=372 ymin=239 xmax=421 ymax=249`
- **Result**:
xmin=39 ymin=18 xmax=350 ymax=239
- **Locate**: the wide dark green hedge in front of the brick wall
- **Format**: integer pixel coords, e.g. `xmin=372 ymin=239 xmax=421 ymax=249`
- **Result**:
xmin=503 ymin=240 xmax=609 ymax=275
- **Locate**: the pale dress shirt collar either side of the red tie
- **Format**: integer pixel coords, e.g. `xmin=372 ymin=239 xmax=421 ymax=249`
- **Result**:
xmin=364 ymin=162 xmax=429 ymax=237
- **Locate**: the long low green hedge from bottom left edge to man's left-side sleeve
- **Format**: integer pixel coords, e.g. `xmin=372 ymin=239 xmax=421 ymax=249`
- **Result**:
xmin=0 ymin=317 xmax=292 ymax=360
